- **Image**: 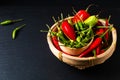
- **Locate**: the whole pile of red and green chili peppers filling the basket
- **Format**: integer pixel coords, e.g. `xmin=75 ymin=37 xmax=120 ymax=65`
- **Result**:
xmin=45 ymin=5 xmax=113 ymax=57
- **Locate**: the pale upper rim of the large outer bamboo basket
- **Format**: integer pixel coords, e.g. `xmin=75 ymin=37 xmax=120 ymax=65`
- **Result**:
xmin=47 ymin=17 xmax=117 ymax=61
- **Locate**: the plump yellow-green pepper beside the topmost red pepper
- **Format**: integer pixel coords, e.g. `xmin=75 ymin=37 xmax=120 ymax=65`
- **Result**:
xmin=84 ymin=15 xmax=98 ymax=27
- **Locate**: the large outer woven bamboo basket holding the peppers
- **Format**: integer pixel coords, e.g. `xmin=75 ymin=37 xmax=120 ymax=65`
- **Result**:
xmin=47 ymin=18 xmax=117 ymax=70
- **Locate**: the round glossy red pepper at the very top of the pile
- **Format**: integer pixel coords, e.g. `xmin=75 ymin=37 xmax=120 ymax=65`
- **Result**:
xmin=72 ymin=10 xmax=90 ymax=23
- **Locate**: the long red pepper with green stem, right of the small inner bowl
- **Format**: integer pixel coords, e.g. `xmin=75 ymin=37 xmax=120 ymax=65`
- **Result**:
xmin=79 ymin=26 xmax=109 ymax=57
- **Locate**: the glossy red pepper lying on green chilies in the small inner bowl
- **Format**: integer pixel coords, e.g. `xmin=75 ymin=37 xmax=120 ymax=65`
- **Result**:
xmin=61 ymin=20 xmax=76 ymax=41
